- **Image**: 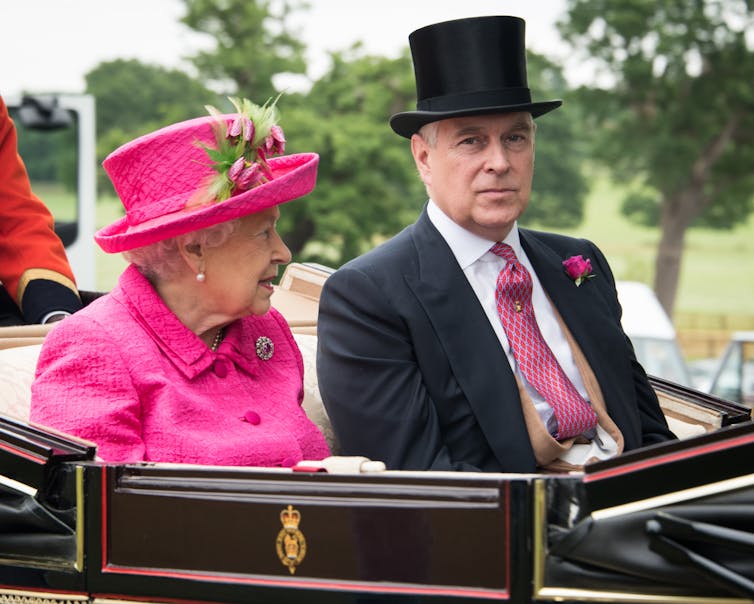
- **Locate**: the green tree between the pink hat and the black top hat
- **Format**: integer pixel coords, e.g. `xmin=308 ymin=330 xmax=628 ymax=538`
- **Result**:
xmin=280 ymin=47 xmax=425 ymax=266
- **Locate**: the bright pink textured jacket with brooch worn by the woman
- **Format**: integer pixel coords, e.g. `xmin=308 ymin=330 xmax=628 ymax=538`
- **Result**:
xmin=31 ymin=266 xmax=329 ymax=466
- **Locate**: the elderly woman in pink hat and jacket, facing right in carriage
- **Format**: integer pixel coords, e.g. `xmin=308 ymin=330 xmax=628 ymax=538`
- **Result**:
xmin=31 ymin=99 xmax=329 ymax=466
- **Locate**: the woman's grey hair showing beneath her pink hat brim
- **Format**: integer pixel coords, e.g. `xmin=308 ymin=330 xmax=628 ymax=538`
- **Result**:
xmin=123 ymin=218 xmax=240 ymax=283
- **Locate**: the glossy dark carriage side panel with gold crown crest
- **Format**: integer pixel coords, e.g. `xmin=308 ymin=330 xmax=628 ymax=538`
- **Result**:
xmin=89 ymin=465 xmax=530 ymax=602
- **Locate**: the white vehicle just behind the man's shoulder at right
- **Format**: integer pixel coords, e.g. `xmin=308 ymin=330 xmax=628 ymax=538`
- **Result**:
xmin=615 ymin=281 xmax=692 ymax=386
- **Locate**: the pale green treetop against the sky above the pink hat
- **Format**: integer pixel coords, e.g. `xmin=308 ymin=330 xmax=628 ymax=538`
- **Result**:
xmin=182 ymin=0 xmax=308 ymax=103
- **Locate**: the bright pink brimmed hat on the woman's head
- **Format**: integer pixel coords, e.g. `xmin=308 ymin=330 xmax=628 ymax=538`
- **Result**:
xmin=94 ymin=102 xmax=319 ymax=253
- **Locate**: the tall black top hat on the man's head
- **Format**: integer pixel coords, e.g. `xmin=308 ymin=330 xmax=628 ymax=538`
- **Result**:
xmin=390 ymin=16 xmax=562 ymax=138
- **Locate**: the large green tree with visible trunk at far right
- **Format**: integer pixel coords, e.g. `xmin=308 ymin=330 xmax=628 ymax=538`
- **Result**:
xmin=559 ymin=0 xmax=754 ymax=314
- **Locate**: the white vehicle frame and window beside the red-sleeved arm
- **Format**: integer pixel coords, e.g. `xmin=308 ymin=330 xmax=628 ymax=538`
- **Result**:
xmin=3 ymin=94 xmax=97 ymax=291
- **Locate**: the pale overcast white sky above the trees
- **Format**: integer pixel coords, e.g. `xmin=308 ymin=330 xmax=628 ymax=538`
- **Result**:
xmin=0 ymin=0 xmax=565 ymax=95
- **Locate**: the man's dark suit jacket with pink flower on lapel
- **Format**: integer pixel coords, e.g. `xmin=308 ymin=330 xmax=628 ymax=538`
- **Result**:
xmin=317 ymin=210 xmax=673 ymax=472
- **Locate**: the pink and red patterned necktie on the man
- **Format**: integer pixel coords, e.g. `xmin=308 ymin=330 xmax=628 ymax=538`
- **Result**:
xmin=490 ymin=243 xmax=597 ymax=440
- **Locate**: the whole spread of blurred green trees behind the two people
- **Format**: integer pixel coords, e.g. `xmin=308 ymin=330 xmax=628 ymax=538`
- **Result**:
xmin=79 ymin=0 xmax=754 ymax=312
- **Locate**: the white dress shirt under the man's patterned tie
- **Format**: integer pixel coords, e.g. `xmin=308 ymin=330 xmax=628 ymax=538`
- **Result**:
xmin=427 ymin=199 xmax=617 ymax=463
